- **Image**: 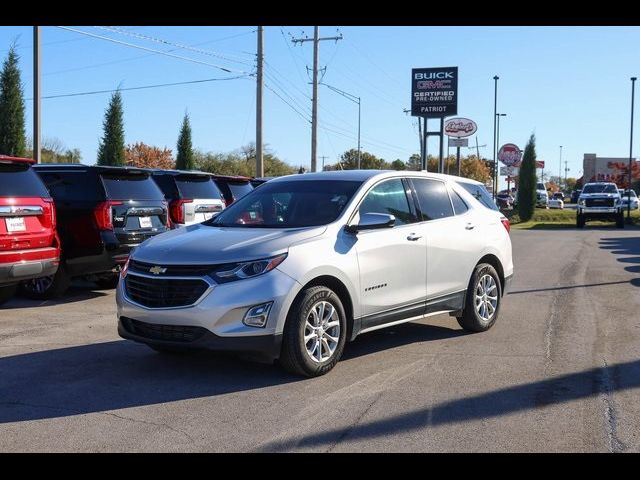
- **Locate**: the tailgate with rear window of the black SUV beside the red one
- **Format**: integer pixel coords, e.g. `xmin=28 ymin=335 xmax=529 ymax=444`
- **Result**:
xmin=100 ymin=171 xmax=168 ymax=246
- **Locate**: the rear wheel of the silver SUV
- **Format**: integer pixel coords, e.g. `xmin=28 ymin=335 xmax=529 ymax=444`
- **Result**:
xmin=457 ymin=263 xmax=502 ymax=332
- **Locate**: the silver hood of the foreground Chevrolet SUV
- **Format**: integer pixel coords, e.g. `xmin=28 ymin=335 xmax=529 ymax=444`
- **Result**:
xmin=131 ymin=224 xmax=327 ymax=265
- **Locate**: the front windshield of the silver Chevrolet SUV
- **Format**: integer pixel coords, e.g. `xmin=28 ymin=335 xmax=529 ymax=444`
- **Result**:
xmin=205 ymin=180 xmax=362 ymax=228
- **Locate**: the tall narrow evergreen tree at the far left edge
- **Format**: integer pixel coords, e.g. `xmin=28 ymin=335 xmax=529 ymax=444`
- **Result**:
xmin=0 ymin=44 xmax=27 ymax=157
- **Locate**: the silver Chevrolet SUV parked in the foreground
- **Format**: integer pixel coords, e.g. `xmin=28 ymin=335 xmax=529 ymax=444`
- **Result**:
xmin=117 ymin=170 xmax=513 ymax=376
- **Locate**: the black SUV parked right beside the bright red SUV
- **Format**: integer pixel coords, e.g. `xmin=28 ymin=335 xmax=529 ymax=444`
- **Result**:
xmin=22 ymin=164 xmax=169 ymax=299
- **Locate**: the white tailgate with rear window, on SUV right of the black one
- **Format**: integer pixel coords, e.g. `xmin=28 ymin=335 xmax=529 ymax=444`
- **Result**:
xmin=175 ymin=174 xmax=224 ymax=225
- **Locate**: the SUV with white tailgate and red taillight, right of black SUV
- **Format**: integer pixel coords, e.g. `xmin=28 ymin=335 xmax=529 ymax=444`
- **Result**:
xmin=151 ymin=170 xmax=224 ymax=228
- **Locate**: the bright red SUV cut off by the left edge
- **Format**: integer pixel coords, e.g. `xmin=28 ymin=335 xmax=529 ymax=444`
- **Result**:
xmin=0 ymin=155 xmax=60 ymax=304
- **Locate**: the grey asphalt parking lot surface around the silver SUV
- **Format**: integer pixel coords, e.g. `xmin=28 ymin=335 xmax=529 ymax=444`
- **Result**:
xmin=0 ymin=227 xmax=640 ymax=452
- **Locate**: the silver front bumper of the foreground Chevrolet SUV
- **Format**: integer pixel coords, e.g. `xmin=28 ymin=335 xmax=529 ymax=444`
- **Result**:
xmin=116 ymin=268 xmax=301 ymax=358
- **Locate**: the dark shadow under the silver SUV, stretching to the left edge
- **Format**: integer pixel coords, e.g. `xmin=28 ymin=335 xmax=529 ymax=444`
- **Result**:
xmin=0 ymin=323 xmax=466 ymax=423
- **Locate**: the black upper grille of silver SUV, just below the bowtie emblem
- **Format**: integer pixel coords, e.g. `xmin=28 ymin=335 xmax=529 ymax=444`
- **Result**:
xmin=124 ymin=272 xmax=209 ymax=308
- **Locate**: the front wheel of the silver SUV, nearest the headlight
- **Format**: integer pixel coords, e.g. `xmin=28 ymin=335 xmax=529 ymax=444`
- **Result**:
xmin=280 ymin=286 xmax=347 ymax=377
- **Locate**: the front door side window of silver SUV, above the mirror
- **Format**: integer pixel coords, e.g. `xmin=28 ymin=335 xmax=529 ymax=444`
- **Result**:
xmin=358 ymin=178 xmax=417 ymax=225
